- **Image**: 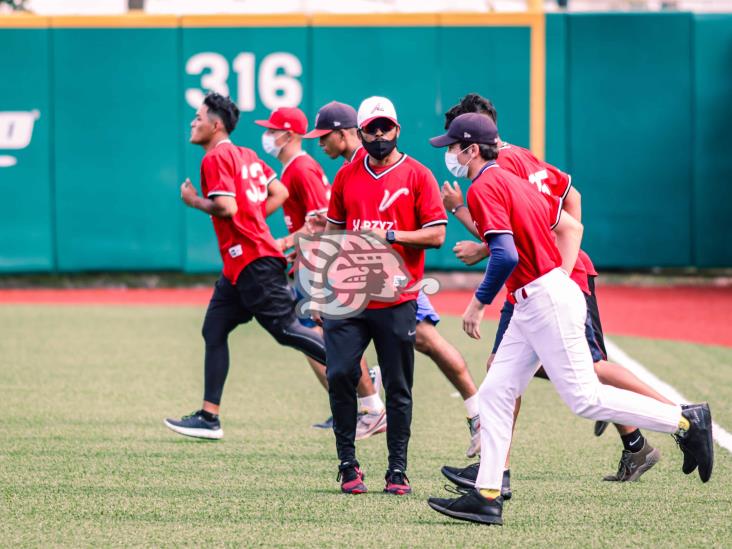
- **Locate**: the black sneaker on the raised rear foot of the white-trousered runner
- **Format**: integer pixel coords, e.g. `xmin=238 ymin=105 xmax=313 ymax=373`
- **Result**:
xmin=674 ymin=402 xmax=714 ymax=482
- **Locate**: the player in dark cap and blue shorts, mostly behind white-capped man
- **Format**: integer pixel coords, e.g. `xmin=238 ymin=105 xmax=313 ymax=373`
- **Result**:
xmin=305 ymin=101 xmax=480 ymax=457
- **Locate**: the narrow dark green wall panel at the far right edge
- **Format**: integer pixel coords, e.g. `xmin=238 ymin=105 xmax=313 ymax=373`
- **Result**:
xmin=684 ymin=15 xmax=732 ymax=267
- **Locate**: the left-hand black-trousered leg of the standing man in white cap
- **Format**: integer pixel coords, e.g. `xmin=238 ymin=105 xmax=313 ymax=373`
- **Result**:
xmin=323 ymin=312 xmax=371 ymax=494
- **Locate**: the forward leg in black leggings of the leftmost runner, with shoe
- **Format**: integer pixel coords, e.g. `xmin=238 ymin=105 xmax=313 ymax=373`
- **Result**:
xmin=164 ymin=276 xmax=252 ymax=439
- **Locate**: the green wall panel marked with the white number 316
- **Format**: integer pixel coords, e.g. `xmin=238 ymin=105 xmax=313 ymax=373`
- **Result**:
xmin=184 ymin=22 xmax=311 ymax=272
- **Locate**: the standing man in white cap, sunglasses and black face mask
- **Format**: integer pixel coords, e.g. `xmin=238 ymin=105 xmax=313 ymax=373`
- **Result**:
xmin=323 ymin=97 xmax=447 ymax=495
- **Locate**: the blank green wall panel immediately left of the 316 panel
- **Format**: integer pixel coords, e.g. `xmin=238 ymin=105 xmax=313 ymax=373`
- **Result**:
xmin=53 ymin=28 xmax=183 ymax=271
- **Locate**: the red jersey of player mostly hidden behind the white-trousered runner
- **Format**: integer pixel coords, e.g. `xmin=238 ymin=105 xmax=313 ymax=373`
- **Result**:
xmin=496 ymin=143 xmax=594 ymax=294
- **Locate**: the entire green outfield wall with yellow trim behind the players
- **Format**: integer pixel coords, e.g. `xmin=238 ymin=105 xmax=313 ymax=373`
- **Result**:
xmin=0 ymin=13 xmax=732 ymax=273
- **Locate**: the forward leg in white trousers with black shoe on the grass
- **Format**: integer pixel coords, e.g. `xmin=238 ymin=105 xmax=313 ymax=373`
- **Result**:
xmin=429 ymin=322 xmax=538 ymax=524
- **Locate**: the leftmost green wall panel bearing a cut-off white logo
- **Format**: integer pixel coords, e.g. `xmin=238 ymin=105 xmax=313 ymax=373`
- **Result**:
xmin=0 ymin=29 xmax=54 ymax=272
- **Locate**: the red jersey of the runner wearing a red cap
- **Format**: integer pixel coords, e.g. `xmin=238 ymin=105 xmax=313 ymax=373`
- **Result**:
xmin=281 ymin=151 xmax=330 ymax=233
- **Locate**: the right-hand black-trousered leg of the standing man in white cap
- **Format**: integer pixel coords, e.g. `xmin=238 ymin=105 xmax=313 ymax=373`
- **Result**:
xmin=372 ymin=301 xmax=417 ymax=495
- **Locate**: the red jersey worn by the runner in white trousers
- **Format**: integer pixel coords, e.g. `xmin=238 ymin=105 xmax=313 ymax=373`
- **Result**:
xmin=467 ymin=164 xmax=562 ymax=292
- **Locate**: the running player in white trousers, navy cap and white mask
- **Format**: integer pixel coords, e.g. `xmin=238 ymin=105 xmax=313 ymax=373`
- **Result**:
xmin=429 ymin=113 xmax=714 ymax=524
